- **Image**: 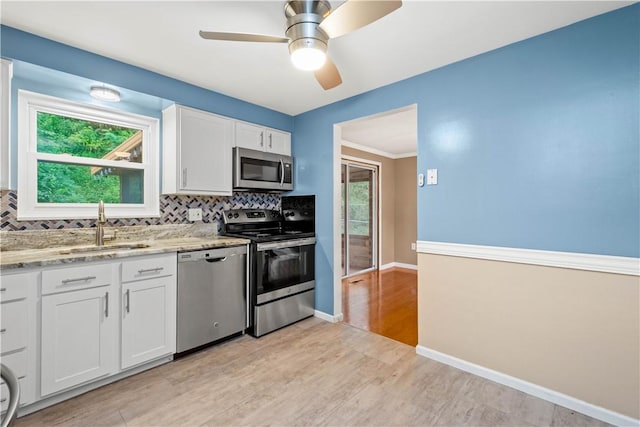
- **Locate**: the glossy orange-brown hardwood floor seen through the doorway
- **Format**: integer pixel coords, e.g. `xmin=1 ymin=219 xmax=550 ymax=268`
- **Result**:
xmin=342 ymin=268 xmax=418 ymax=347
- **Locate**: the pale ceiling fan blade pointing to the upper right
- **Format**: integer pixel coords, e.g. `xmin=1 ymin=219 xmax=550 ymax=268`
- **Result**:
xmin=320 ymin=0 xmax=402 ymax=39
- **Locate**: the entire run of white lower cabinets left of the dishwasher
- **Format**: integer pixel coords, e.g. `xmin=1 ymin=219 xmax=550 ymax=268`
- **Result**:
xmin=0 ymin=253 xmax=177 ymax=411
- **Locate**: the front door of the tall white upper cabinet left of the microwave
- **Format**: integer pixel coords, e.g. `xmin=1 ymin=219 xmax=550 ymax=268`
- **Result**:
xmin=178 ymin=108 xmax=233 ymax=195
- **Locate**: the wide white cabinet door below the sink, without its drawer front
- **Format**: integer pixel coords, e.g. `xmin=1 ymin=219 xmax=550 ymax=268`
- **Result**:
xmin=41 ymin=286 xmax=118 ymax=396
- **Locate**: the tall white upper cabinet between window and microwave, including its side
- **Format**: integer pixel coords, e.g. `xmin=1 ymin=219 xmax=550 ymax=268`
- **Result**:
xmin=162 ymin=105 xmax=234 ymax=196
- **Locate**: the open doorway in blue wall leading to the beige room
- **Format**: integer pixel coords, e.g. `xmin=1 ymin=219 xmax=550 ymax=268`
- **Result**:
xmin=333 ymin=105 xmax=418 ymax=346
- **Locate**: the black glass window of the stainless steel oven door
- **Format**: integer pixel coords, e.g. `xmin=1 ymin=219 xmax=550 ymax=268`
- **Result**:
xmin=256 ymin=245 xmax=314 ymax=294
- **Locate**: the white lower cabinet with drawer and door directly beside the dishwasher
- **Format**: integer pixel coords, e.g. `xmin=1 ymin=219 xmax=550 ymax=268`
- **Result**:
xmin=121 ymin=254 xmax=176 ymax=369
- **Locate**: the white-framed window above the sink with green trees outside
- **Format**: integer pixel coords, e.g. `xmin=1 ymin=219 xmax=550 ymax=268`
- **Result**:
xmin=18 ymin=90 xmax=159 ymax=220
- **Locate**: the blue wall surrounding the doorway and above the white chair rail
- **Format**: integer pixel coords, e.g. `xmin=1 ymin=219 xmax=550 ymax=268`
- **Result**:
xmin=294 ymin=4 xmax=640 ymax=313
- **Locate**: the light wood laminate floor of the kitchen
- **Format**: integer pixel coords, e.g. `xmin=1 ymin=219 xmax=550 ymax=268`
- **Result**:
xmin=16 ymin=318 xmax=605 ymax=427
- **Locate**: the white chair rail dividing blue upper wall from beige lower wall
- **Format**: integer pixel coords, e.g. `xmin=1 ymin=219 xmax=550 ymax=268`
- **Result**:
xmin=417 ymin=241 xmax=640 ymax=276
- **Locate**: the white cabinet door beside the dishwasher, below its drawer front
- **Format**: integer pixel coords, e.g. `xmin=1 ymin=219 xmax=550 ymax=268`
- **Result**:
xmin=122 ymin=276 xmax=176 ymax=369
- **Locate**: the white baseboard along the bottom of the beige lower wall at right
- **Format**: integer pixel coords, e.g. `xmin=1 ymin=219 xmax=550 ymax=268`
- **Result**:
xmin=416 ymin=345 xmax=640 ymax=426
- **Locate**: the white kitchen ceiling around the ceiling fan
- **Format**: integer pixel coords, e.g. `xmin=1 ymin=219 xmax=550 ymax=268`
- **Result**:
xmin=0 ymin=0 xmax=632 ymax=115
